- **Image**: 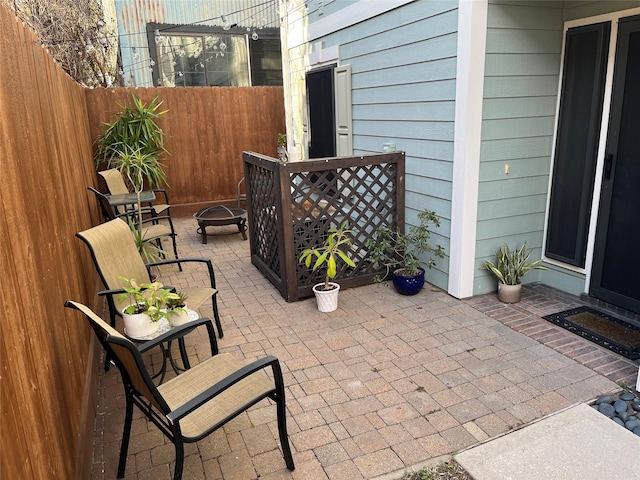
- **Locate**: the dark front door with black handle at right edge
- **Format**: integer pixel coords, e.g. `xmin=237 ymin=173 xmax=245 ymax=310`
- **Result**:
xmin=589 ymin=16 xmax=640 ymax=313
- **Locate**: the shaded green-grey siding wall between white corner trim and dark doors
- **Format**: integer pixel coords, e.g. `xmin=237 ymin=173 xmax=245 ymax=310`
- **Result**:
xmin=474 ymin=0 xmax=563 ymax=294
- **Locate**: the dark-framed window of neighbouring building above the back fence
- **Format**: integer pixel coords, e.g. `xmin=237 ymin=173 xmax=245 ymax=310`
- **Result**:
xmin=147 ymin=24 xmax=282 ymax=87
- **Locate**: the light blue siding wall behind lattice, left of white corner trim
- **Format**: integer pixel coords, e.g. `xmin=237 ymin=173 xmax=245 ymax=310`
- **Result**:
xmin=309 ymin=0 xmax=458 ymax=289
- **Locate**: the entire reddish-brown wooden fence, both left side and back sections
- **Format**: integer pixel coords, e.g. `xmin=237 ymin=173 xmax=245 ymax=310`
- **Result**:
xmin=0 ymin=3 xmax=284 ymax=479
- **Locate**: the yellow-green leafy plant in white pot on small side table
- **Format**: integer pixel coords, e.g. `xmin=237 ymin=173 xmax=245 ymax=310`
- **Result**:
xmin=118 ymin=278 xmax=178 ymax=338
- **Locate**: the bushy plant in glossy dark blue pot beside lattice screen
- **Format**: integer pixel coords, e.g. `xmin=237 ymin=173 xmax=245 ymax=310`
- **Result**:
xmin=365 ymin=210 xmax=444 ymax=295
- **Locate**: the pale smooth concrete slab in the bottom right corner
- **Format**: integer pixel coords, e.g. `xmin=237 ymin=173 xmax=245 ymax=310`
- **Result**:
xmin=455 ymin=404 xmax=640 ymax=480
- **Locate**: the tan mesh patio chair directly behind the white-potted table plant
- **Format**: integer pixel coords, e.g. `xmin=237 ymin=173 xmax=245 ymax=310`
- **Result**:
xmin=76 ymin=218 xmax=223 ymax=338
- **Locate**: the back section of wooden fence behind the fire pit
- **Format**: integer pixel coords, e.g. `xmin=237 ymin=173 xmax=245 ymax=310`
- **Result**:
xmin=86 ymin=87 xmax=285 ymax=213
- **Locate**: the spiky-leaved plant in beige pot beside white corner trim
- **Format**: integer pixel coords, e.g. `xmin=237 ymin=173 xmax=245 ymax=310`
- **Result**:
xmin=484 ymin=242 xmax=548 ymax=303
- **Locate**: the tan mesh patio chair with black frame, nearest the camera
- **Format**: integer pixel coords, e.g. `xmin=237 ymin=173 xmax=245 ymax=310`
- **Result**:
xmin=65 ymin=301 xmax=295 ymax=480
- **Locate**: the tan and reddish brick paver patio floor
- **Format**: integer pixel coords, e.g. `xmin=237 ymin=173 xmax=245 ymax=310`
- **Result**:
xmin=92 ymin=217 xmax=638 ymax=480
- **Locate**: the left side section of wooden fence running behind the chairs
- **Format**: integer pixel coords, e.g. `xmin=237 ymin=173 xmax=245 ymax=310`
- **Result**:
xmin=0 ymin=4 xmax=96 ymax=479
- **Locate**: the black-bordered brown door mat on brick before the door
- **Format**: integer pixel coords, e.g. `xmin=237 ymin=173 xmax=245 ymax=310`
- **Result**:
xmin=542 ymin=307 xmax=640 ymax=360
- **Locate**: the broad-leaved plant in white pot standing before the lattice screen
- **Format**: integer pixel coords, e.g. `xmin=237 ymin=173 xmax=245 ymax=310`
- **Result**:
xmin=299 ymin=220 xmax=356 ymax=312
